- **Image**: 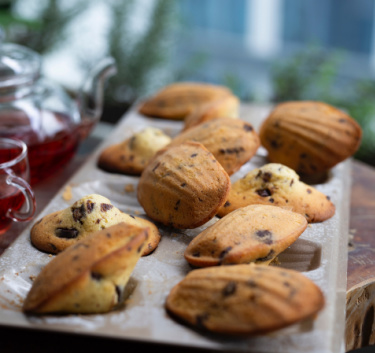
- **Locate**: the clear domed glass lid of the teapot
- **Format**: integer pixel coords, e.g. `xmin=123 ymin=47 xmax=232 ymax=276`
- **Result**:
xmin=0 ymin=43 xmax=41 ymax=89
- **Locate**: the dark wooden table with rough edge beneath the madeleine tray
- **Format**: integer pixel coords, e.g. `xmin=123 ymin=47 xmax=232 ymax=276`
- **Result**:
xmin=0 ymin=124 xmax=375 ymax=353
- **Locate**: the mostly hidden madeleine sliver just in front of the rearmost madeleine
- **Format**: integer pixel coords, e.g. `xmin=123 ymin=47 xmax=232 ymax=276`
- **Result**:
xmin=184 ymin=94 xmax=240 ymax=131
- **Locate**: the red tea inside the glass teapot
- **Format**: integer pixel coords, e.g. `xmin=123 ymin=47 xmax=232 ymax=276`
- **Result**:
xmin=0 ymin=111 xmax=80 ymax=185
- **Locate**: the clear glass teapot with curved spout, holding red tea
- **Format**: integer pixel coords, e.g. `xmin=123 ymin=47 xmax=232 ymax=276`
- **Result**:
xmin=0 ymin=43 xmax=116 ymax=184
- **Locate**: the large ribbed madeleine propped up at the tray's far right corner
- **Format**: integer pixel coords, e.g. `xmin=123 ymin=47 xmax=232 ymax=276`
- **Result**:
xmin=259 ymin=101 xmax=362 ymax=175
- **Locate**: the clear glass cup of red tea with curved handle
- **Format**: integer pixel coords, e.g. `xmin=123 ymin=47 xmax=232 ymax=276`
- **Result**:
xmin=0 ymin=138 xmax=36 ymax=234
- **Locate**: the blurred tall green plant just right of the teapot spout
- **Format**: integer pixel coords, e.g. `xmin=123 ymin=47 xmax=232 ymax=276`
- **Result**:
xmin=107 ymin=0 xmax=175 ymax=103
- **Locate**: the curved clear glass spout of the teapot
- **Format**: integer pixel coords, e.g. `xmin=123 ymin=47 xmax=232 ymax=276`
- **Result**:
xmin=78 ymin=57 xmax=117 ymax=126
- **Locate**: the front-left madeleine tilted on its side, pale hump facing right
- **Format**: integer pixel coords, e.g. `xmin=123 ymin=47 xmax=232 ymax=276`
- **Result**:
xmin=23 ymin=223 xmax=148 ymax=314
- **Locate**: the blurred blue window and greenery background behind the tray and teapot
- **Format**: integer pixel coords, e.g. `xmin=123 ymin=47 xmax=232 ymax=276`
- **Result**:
xmin=0 ymin=0 xmax=375 ymax=165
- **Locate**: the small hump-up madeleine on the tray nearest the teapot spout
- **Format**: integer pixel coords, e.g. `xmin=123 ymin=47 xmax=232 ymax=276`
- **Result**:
xmin=98 ymin=127 xmax=172 ymax=175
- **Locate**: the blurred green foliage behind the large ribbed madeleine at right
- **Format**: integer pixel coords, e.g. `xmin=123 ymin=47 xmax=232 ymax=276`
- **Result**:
xmin=272 ymin=46 xmax=375 ymax=165
